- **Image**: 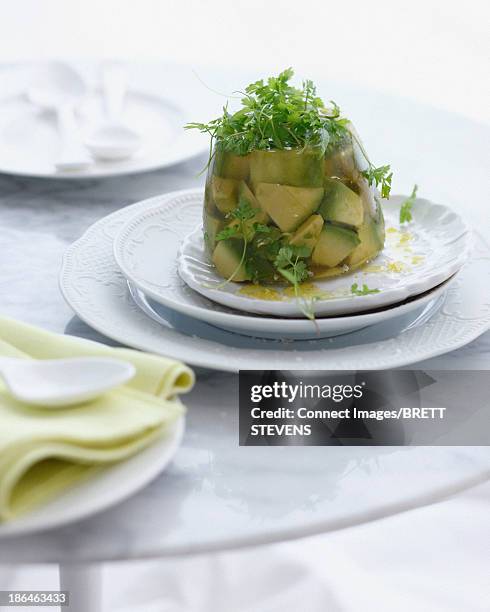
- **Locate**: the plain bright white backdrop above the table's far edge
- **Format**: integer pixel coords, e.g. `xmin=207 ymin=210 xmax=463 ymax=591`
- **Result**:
xmin=0 ymin=0 xmax=490 ymax=121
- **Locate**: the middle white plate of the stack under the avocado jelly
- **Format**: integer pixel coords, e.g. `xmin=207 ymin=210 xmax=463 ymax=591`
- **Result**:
xmin=114 ymin=191 xmax=462 ymax=339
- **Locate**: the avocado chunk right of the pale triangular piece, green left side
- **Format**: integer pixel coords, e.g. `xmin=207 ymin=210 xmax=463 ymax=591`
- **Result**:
xmin=318 ymin=178 xmax=364 ymax=227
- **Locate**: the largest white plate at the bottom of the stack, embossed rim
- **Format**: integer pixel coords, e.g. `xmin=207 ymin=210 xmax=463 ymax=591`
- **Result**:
xmin=60 ymin=192 xmax=490 ymax=372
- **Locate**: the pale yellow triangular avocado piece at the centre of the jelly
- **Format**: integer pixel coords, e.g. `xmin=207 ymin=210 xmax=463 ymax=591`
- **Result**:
xmin=255 ymin=183 xmax=323 ymax=232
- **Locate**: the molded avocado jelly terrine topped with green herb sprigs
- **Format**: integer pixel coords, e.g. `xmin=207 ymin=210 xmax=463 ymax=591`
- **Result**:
xmin=187 ymin=69 xmax=392 ymax=285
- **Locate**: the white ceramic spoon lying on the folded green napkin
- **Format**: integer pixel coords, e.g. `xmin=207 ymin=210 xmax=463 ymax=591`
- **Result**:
xmin=0 ymin=357 xmax=135 ymax=408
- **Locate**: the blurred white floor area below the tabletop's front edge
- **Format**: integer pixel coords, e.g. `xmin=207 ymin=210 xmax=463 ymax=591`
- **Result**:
xmin=0 ymin=483 xmax=490 ymax=612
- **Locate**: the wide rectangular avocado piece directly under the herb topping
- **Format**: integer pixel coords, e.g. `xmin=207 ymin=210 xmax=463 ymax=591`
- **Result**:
xmin=250 ymin=148 xmax=324 ymax=187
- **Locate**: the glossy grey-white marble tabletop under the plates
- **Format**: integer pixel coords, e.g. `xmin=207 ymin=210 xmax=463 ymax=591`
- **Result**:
xmin=0 ymin=75 xmax=490 ymax=563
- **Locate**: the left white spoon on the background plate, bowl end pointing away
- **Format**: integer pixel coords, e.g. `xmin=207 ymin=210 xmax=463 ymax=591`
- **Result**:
xmin=27 ymin=62 xmax=93 ymax=170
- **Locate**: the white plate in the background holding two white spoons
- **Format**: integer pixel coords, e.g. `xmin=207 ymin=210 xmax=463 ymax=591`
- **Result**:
xmin=0 ymin=66 xmax=207 ymax=179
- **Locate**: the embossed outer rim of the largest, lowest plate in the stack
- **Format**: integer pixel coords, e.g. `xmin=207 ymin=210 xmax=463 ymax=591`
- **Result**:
xmin=59 ymin=190 xmax=490 ymax=372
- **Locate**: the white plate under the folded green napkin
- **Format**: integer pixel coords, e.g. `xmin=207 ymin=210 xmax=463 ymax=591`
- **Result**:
xmin=0 ymin=417 xmax=185 ymax=539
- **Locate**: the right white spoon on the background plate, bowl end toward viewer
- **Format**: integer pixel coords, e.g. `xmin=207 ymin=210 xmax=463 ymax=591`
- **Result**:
xmin=86 ymin=64 xmax=141 ymax=161
